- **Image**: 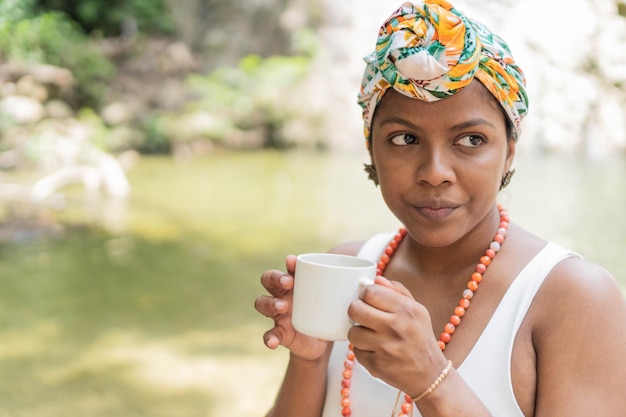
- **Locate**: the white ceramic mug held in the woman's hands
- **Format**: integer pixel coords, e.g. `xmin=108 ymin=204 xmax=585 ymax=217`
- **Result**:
xmin=292 ymin=253 xmax=376 ymax=340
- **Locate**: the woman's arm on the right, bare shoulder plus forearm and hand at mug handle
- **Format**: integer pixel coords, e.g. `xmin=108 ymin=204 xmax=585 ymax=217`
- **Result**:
xmin=350 ymin=255 xmax=626 ymax=417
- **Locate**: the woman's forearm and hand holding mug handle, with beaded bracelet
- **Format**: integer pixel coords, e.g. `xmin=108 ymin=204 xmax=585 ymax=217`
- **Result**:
xmin=349 ymin=277 xmax=491 ymax=417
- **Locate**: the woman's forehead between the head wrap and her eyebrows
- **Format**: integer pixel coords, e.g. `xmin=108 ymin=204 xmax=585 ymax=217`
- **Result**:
xmin=373 ymin=80 xmax=506 ymax=128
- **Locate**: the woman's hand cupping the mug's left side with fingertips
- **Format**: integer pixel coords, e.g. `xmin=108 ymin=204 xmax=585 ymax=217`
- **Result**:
xmin=254 ymin=255 xmax=330 ymax=360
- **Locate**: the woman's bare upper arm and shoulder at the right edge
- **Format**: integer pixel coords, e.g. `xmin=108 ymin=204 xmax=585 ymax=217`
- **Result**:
xmin=533 ymin=259 xmax=626 ymax=417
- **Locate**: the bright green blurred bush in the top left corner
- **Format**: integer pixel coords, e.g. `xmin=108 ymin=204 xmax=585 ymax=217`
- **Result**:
xmin=0 ymin=10 xmax=115 ymax=106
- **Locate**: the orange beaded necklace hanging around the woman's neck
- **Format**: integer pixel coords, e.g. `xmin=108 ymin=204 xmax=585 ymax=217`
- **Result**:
xmin=341 ymin=205 xmax=509 ymax=417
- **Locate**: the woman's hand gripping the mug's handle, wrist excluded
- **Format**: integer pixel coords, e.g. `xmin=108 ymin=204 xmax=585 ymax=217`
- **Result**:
xmin=348 ymin=276 xmax=446 ymax=395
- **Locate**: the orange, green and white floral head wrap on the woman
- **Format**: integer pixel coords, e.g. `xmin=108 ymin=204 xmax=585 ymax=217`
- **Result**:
xmin=358 ymin=0 xmax=528 ymax=139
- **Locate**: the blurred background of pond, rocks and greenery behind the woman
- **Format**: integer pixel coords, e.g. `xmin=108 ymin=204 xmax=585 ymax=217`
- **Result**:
xmin=0 ymin=0 xmax=626 ymax=417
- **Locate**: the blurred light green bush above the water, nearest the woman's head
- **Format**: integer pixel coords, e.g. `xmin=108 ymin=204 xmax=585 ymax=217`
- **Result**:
xmin=183 ymin=55 xmax=312 ymax=147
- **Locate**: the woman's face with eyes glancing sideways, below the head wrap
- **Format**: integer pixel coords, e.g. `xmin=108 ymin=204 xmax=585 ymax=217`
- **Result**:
xmin=371 ymin=81 xmax=515 ymax=247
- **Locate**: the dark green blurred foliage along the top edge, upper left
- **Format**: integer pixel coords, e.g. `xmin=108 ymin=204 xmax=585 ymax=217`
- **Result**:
xmin=36 ymin=0 xmax=175 ymax=36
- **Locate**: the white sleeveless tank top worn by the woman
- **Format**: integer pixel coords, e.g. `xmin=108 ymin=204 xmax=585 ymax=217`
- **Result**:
xmin=322 ymin=233 xmax=578 ymax=417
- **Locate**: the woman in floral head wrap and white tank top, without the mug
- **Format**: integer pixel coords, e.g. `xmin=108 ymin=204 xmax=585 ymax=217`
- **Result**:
xmin=255 ymin=0 xmax=626 ymax=417
